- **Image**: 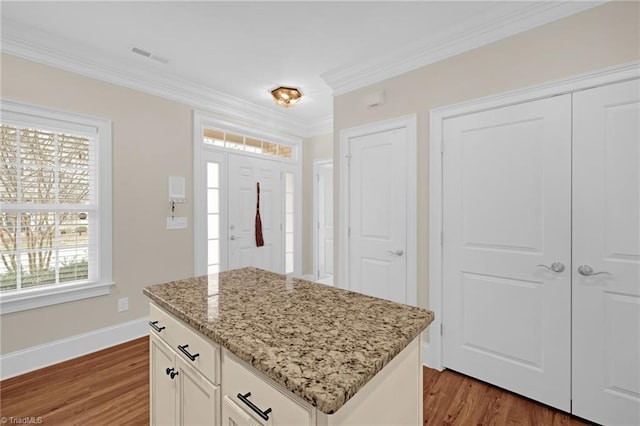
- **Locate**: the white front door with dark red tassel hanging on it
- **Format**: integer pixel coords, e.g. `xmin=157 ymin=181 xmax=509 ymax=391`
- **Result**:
xmin=227 ymin=154 xmax=284 ymax=273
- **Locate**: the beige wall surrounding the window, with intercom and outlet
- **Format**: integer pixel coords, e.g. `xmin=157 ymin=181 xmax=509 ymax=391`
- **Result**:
xmin=0 ymin=55 xmax=193 ymax=354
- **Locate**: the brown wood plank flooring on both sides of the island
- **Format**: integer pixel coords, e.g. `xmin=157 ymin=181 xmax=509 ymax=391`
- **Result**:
xmin=0 ymin=337 xmax=589 ymax=426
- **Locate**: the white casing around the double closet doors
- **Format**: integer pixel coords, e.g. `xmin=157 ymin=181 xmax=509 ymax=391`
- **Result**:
xmin=423 ymin=62 xmax=640 ymax=371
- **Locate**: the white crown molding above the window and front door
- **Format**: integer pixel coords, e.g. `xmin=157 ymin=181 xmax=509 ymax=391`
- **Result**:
xmin=2 ymin=18 xmax=333 ymax=137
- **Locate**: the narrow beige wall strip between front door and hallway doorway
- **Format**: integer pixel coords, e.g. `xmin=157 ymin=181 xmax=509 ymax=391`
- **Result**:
xmin=302 ymin=133 xmax=333 ymax=274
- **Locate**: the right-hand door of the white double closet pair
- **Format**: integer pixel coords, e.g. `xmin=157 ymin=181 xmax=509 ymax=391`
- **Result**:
xmin=572 ymin=80 xmax=640 ymax=425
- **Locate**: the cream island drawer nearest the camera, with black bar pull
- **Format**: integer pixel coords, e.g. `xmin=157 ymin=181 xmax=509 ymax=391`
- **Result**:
xmin=222 ymin=350 xmax=315 ymax=426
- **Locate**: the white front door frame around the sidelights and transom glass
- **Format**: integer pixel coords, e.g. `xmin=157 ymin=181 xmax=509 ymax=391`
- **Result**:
xmin=193 ymin=110 xmax=302 ymax=276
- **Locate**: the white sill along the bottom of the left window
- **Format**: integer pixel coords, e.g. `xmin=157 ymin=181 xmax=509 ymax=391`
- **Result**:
xmin=0 ymin=282 xmax=113 ymax=315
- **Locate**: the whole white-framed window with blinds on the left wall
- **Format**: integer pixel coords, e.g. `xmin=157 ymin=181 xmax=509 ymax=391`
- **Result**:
xmin=0 ymin=102 xmax=111 ymax=313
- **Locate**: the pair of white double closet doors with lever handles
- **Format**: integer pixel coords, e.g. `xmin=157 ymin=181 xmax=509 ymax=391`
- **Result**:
xmin=443 ymin=80 xmax=640 ymax=425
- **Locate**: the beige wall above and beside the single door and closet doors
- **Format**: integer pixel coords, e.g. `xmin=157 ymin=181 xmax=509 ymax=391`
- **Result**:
xmin=334 ymin=2 xmax=640 ymax=307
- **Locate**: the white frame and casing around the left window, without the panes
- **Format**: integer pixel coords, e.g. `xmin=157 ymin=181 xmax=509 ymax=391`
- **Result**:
xmin=0 ymin=100 xmax=113 ymax=315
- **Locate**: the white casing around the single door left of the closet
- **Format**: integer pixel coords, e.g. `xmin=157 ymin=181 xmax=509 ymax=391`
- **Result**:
xmin=334 ymin=114 xmax=418 ymax=306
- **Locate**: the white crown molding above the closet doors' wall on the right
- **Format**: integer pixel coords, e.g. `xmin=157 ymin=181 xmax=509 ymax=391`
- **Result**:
xmin=321 ymin=0 xmax=605 ymax=96
